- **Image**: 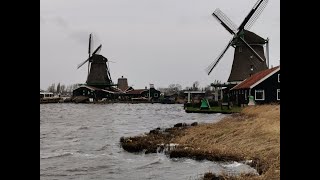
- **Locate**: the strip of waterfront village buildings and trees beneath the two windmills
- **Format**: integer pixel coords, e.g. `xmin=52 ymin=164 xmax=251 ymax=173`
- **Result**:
xmin=40 ymin=66 xmax=280 ymax=112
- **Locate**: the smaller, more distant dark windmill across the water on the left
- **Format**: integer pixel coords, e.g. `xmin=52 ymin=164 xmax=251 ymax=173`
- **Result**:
xmin=77 ymin=34 xmax=114 ymax=88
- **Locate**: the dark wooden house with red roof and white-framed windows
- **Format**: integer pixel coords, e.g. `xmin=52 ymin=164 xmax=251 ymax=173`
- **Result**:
xmin=228 ymin=66 xmax=280 ymax=105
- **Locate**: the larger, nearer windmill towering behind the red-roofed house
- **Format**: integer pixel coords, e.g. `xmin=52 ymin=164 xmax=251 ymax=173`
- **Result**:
xmin=206 ymin=0 xmax=269 ymax=82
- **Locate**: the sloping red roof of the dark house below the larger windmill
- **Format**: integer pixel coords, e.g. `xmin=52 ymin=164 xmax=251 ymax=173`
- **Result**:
xmin=230 ymin=66 xmax=280 ymax=90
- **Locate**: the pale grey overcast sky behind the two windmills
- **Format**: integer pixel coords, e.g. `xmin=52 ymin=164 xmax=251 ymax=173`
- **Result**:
xmin=40 ymin=0 xmax=280 ymax=89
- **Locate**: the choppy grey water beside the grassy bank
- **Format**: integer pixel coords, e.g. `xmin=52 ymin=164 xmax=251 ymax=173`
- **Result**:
xmin=40 ymin=103 xmax=254 ymax=180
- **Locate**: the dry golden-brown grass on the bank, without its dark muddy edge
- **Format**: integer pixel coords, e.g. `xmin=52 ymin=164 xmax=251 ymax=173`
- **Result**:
xmin=172 ymin=105 xmax=280 ymax=179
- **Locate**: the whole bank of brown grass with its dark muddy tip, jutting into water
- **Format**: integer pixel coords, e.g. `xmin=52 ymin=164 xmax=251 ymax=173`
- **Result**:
xmin=121 ymin=105 xmax=280 ymax=179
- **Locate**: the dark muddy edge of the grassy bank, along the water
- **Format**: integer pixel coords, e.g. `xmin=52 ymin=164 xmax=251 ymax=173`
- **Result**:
xmin=120 ymin=122 xmax=262 ymax=179
